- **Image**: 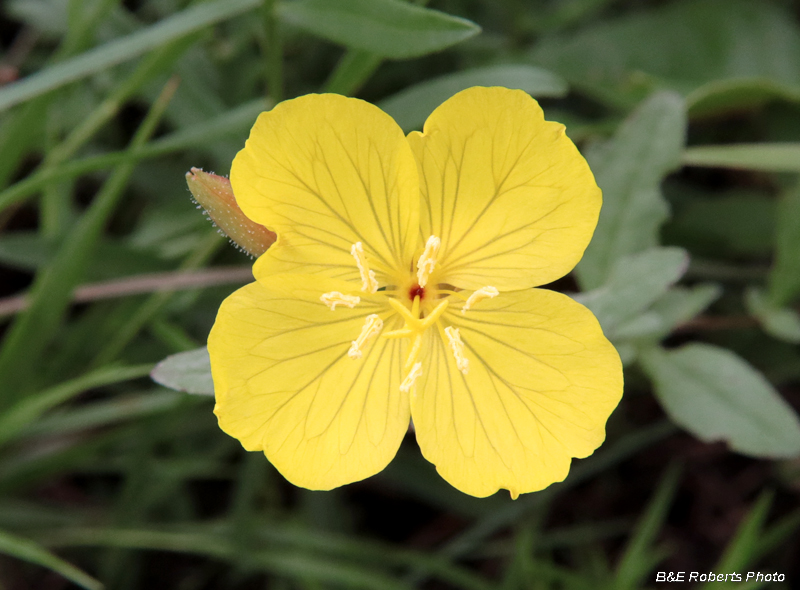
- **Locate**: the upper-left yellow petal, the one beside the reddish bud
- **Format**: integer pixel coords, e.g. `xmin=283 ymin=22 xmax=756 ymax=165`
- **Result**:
xmin=231 ymin=94 xmax=419 ymax=284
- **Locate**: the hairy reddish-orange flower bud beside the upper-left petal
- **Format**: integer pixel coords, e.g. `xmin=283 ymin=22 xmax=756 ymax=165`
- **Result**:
xmin=186 ymin=168 xmax=275 ymax=257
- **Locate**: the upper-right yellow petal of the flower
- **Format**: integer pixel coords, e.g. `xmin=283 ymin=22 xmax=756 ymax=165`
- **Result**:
xmin=406 ymin=87 xmax=602 ymax=291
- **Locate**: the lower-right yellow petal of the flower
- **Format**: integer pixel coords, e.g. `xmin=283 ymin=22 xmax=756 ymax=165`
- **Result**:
xmin=411 ymin=289 xmax=622 ymax=497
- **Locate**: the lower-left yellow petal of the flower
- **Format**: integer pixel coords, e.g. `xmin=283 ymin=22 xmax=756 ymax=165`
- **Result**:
xmin=208 ymin=275 xmax=409 ymax=490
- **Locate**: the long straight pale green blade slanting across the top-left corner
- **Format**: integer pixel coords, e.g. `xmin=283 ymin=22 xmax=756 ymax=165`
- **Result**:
xmin=0 ymin=0 xmax=261 ymax=111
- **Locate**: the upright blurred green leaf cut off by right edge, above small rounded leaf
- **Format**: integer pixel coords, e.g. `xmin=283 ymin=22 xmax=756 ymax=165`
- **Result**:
xmin=769 ymin=184 xmax=800 ymax=307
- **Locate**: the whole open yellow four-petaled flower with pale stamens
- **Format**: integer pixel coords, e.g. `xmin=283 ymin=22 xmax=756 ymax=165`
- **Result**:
xmin=208 ymin=88 xmax=622 ymax=497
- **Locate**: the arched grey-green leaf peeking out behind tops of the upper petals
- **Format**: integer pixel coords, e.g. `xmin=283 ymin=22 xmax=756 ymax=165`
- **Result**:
xmin=378 ymin=64 xmax=568 ymax=132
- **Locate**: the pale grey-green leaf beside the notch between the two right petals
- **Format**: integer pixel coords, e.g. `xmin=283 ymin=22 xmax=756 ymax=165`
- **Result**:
xmin=575 ymin=248 xmax=689 ymax=339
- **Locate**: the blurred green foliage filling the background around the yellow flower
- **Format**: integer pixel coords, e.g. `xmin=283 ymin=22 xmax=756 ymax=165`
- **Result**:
xmin=0 ymin=0 xmax=800 ymax=590
